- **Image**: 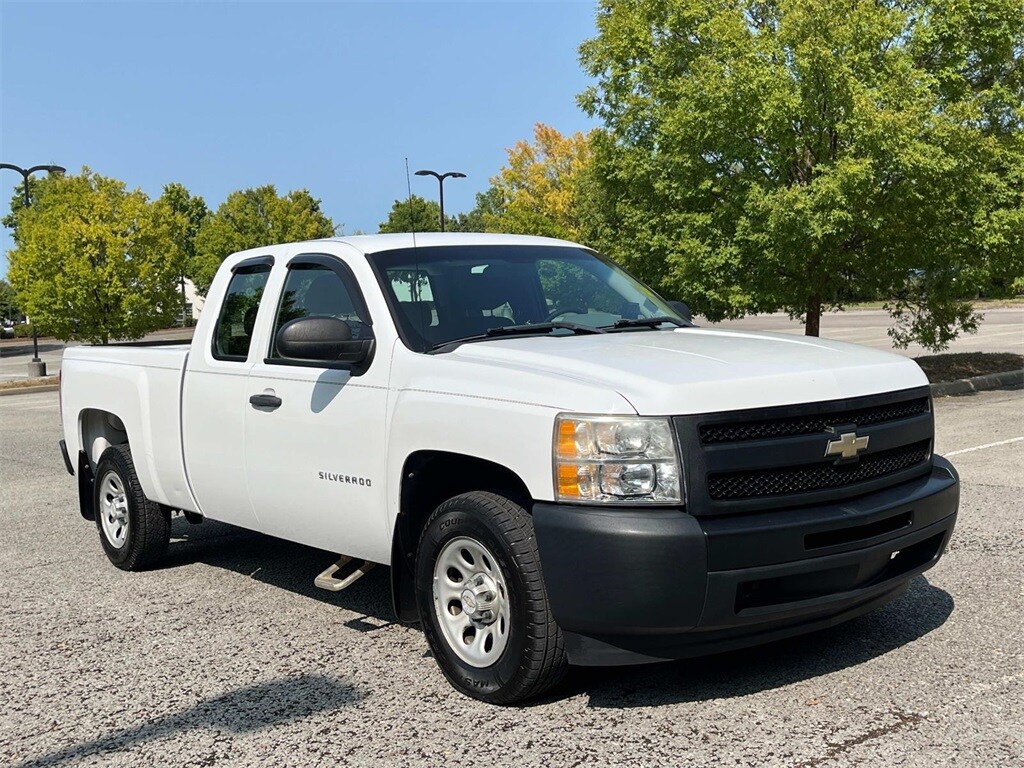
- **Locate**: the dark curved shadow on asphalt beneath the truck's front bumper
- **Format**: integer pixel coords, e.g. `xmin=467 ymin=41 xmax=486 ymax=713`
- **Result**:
xmin=557 ymin=577 xmax=953 ymax=709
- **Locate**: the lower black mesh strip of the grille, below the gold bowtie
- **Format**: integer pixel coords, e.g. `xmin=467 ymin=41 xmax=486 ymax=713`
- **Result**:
xmin=708 ymin=440 xmax=931 ymax=501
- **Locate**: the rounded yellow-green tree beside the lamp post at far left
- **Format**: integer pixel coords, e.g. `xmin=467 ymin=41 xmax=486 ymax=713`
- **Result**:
xmin=8 ymin=168 xmax=181 ymax=344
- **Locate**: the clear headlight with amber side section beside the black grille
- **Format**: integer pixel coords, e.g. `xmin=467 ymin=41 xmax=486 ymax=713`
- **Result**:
xmin=554 ymin=414 xmax=683 ymax=504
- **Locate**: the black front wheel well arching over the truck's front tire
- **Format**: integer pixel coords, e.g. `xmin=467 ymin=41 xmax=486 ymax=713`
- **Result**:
xmin=391 ymin=451 xmax=530 ymax=622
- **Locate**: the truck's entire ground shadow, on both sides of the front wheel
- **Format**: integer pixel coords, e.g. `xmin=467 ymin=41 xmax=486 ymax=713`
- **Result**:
xmin=157 ymin=518 xmax=953 ymax=709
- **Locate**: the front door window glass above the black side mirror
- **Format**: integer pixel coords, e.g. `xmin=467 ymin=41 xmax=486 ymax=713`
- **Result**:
xmin=270 ymin=264 xmax=373 ymax=359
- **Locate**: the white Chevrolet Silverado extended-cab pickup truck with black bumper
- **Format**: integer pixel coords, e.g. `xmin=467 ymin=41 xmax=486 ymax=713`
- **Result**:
xmin=60 ymin=234 xmax=959 ymax=703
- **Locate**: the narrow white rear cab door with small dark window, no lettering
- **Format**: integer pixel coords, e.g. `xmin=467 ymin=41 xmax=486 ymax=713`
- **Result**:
xmin=181 ymin=256 xmax=273 ymax=529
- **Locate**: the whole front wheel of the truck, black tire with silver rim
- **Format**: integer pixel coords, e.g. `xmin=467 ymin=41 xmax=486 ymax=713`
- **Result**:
xmin=415 ymin=492 xmax=568 ymax=705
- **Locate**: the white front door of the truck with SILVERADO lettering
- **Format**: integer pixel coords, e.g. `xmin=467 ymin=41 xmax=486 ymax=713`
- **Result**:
xmin=245 ymin=254 xmax=390 ymax=562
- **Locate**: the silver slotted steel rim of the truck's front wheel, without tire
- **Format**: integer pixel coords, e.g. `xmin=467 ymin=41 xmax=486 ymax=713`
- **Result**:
xmin=433 ymin=537 xmax=512 ymax=669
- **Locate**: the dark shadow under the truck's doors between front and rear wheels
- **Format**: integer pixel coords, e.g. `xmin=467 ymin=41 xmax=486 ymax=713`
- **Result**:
xmin=161 ymin=517 xmax=395 ymax=632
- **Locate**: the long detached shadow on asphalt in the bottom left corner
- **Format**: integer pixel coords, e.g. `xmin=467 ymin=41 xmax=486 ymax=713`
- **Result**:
xmin=14 ymin=675 xmax=361 ymax=768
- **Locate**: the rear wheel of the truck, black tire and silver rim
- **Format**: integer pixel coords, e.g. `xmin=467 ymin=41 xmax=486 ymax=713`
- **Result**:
xmin=93 ymin=445 xmax=171 ymax=570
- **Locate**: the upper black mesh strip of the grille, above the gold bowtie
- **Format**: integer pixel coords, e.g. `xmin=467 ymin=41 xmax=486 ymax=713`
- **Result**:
xmin=700 ymin=397 xmax=928 ymax=444
